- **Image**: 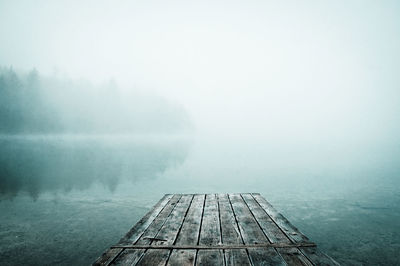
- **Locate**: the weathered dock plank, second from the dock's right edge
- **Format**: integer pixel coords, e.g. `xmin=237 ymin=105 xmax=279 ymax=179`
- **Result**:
xmin=242 ymin=194 xmax=312 ymax=265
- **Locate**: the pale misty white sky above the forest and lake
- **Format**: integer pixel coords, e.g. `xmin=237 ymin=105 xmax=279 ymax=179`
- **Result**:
xmin=0 ymin=0 xmax=400 ymax=140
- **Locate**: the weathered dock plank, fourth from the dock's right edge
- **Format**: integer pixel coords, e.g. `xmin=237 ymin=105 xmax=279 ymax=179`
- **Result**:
xmin=218 ymin=194 xmax=251 ymax=265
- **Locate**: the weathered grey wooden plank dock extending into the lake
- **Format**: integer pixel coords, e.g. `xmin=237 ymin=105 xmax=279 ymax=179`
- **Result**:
xmin=94 ymin=193 xmax=338 ymax=265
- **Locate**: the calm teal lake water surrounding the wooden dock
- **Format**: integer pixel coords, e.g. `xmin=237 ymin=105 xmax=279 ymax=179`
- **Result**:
xmin=0 ymin=136 xmax=400 ymax=265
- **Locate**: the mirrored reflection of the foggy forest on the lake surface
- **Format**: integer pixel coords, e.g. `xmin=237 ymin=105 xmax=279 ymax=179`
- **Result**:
xmin=0 ymin=138 xmax=188 ymax=198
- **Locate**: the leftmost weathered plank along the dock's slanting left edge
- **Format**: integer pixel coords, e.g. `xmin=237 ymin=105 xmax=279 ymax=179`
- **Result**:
xmin=93 ymin=194 xmax=173 ymax=265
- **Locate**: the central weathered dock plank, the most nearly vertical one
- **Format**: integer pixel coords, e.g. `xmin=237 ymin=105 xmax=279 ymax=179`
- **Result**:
xmin=196 ymin=194 xmax=224 ymax=265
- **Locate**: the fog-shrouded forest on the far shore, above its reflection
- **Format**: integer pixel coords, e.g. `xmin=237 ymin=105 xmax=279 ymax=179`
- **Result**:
xmin=0 ymin=68 xmax=190 ymax=134
